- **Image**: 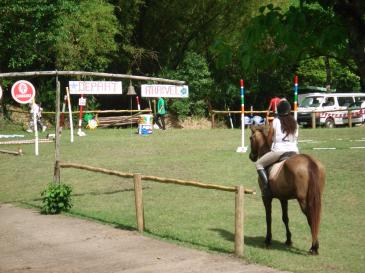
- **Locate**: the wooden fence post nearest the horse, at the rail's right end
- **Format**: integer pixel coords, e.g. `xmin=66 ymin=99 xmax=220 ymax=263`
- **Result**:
xmin=234 ymin=186 xmax=245 ymax=257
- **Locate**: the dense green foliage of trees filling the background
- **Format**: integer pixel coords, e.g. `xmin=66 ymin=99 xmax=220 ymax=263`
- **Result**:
xmin=0 ymin=0 xmax=365 ymax=117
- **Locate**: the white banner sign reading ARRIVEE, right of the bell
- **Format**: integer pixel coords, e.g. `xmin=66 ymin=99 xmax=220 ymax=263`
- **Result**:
xmin=141 ymin=84 xmax=189 ymax=98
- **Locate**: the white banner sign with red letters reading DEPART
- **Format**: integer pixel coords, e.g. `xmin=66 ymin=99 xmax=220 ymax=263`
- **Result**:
xmin=68 ymin=81 xmax=123 ymax=95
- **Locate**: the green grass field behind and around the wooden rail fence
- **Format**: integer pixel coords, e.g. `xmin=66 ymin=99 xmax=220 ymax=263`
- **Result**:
xmin=0 ymin=123 xmax=365 ymax=272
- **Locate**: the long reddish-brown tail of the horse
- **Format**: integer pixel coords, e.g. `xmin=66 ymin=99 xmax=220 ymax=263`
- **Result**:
xmin=304 ymin=155 xmax=324 ymax=240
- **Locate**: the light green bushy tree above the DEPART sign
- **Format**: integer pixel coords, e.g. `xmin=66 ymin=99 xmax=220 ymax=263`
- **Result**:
xmin=55 ymin=0 xmax=118 ymax=71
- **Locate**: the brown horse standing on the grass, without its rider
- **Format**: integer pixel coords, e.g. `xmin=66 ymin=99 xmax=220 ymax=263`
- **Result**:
xmin=249 ymin=126 xmax=326 ymax=255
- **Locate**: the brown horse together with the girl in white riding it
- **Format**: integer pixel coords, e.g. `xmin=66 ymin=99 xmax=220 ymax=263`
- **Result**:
xmin=249 ymin=100 xmax=325 ymax=255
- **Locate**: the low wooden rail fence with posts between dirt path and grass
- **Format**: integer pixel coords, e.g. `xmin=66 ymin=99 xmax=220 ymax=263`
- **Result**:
xmin=56 ymin=161 xmax=255 ymax=256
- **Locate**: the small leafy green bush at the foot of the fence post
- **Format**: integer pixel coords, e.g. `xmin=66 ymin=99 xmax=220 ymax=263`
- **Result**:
xmin=41 ymin=183 xmax=72 ymax=214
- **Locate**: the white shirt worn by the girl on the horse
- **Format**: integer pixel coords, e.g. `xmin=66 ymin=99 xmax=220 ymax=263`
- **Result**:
xmin=271 ymin=118 xmax=299 ymax=153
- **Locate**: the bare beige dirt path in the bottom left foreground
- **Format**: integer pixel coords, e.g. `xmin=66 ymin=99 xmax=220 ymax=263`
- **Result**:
xmin=0 ymin=204 xmax=290 ymax=273
